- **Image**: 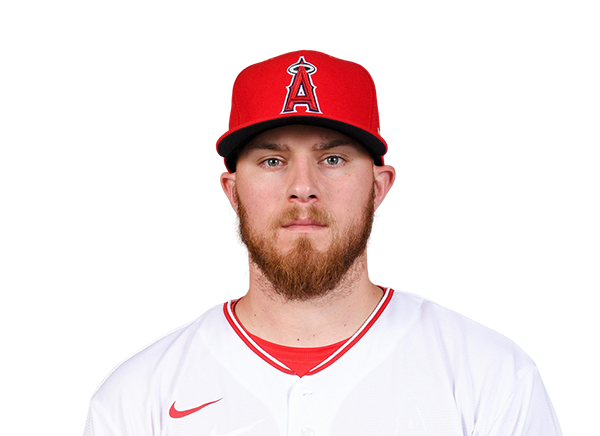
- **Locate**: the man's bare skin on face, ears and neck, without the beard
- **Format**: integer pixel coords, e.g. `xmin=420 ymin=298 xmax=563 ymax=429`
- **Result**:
xmin=221 ymin=125 xmax=394 ymax=347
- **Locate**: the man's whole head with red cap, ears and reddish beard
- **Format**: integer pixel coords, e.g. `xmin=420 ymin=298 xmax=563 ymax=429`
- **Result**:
xmin=217 ymin=52 xmax=393 ymax=301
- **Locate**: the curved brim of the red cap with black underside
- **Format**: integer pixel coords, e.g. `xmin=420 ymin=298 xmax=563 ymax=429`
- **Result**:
xmin=217 ymin=115 xmax=386 ymax=172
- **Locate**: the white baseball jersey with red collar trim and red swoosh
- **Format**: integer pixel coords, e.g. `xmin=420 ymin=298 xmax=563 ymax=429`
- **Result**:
xmin=86 ymin=289 xmax=557 ymax=436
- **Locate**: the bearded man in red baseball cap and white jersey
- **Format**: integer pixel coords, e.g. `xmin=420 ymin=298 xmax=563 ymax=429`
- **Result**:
xmin=87 ymin=52 xmax=556 ymax=436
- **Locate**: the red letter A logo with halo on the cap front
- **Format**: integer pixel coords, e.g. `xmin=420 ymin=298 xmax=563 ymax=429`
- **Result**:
xmin=281 ymin=56 xmax=322 ymax=114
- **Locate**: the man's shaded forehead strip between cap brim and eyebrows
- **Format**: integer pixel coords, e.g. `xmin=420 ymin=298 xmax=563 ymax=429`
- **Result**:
xmin=239 ymin=125 xmax=369 ymax=157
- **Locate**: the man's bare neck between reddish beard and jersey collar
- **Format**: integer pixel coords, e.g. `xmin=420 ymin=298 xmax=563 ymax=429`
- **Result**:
xmin=235 ymin=256 xmax=383 ymax=347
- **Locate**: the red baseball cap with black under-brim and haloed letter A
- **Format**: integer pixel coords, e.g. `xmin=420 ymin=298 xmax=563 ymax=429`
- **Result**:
xmin=217 ymin=51 xmax=387 ymax=172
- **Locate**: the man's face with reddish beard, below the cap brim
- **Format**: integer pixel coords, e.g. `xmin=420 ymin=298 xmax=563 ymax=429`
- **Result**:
xmin=226 ymin=125 xmax=390 ymax=301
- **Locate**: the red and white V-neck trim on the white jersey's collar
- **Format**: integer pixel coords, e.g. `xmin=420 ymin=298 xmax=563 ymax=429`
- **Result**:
xmin=223 ymin=288 xmax=394 ymax=375
